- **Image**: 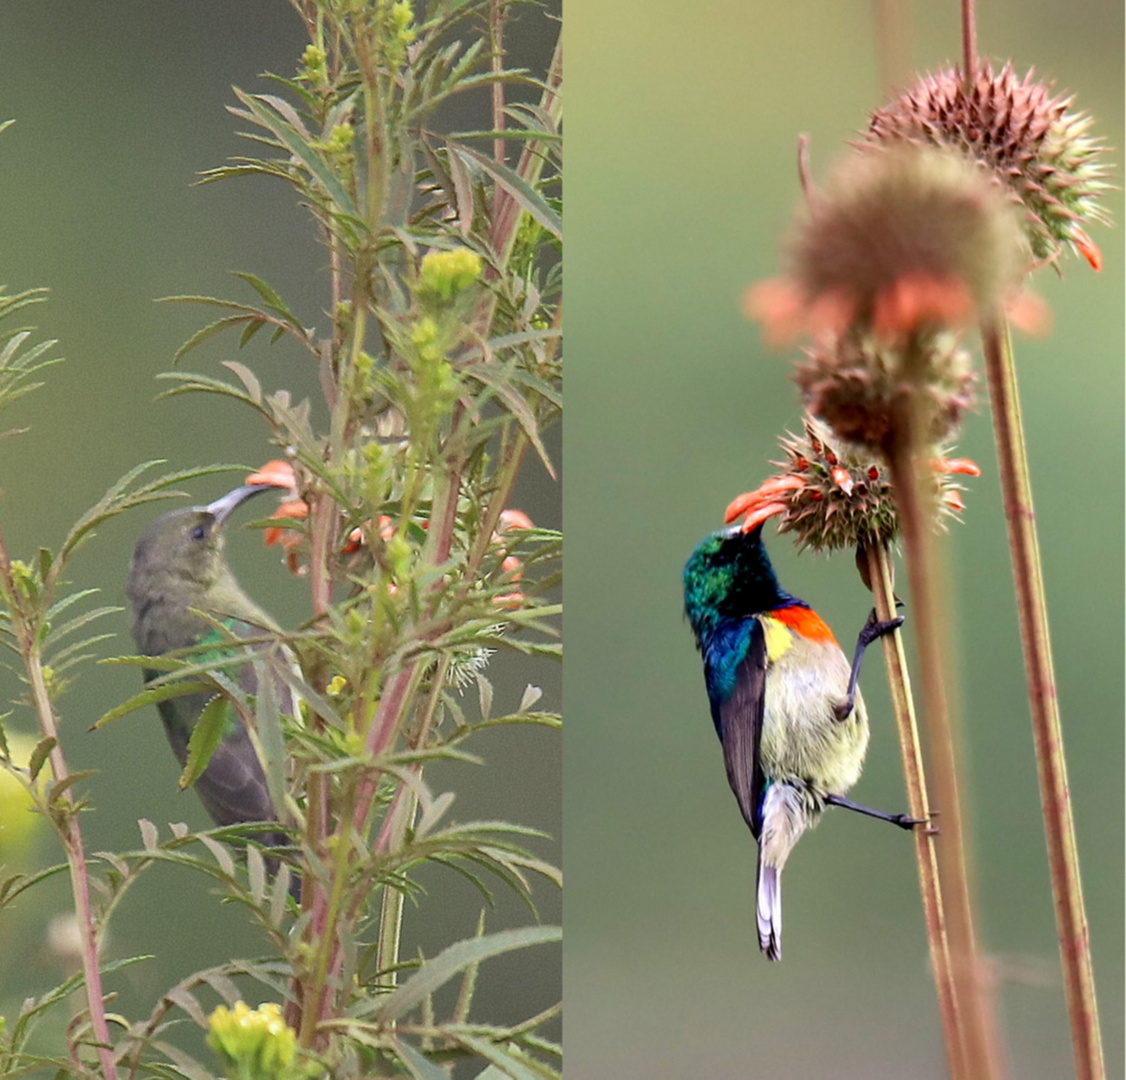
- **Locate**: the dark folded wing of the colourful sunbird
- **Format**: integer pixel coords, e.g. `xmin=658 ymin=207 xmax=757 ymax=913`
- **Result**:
xmin=718 ymin=619 xmax=767 ymax=840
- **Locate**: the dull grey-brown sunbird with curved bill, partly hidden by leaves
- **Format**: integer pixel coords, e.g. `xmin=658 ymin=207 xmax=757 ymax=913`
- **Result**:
xmin=125 ymin=484 xmax=296 ymax=892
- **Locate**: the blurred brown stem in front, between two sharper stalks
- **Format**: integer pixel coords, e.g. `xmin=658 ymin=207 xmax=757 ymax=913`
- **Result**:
xmin=888 ymin=432 xmax=1003 ymax=1080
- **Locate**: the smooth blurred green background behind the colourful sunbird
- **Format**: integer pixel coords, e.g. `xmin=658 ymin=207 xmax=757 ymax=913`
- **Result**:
xmin=564 ymin=0 xmax=1124 ymax=1080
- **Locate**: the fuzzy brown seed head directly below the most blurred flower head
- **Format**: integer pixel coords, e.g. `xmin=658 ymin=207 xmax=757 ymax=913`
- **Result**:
xmin=793 ymin=332 xmax=974 ymax=450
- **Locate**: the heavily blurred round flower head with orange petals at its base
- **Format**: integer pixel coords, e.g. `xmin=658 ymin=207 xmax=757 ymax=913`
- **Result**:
xmin=745 ymin=143 xmax=1028 ymax=341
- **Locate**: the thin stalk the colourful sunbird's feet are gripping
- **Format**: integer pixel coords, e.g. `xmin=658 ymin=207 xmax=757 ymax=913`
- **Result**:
xmin=866 ymin=544 xmax=971 ymax=1080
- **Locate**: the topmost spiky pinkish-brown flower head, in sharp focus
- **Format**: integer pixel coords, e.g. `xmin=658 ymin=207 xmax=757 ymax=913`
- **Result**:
xmin=865 ymin=61 xmax=1108 ymax=270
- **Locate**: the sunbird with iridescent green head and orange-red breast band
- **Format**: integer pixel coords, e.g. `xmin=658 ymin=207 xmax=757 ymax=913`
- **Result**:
xmin=683 ymin=525 xmax=921 ymax=959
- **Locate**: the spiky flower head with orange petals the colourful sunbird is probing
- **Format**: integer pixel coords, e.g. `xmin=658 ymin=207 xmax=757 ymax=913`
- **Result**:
xmin=725 ymin=416 xmax=981 ymax=552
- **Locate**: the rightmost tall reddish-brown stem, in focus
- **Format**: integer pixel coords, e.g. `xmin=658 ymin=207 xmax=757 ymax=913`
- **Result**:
xmin=982 ymin=321 xmax=1106 ymax=1080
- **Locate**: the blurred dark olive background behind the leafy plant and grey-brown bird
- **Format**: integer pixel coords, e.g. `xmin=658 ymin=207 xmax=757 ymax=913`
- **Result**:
xmin=0 ymin=0 xmax=561 ymax=1063
